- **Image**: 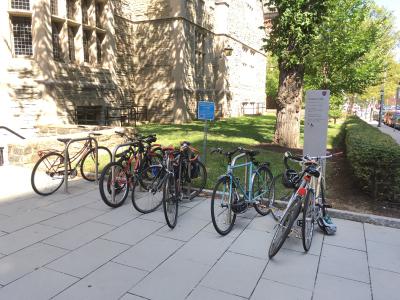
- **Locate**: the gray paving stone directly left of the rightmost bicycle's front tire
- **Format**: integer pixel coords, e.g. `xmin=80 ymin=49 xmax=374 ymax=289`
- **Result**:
xmin=229 ymin=229 xmax=272 ymax=260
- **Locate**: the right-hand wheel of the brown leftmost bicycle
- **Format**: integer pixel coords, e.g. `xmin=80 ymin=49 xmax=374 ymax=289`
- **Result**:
xmin=81 ymin=146 xmax=111 ymax=181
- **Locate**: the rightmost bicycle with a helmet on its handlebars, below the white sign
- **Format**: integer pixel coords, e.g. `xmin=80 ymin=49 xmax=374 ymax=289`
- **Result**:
xmin=268 ymin=152 xmax=338 ymax=258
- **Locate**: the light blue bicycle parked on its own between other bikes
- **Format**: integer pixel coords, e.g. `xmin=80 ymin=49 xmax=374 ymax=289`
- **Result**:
xmin=211 ymin=147 xmax=274 ymax=235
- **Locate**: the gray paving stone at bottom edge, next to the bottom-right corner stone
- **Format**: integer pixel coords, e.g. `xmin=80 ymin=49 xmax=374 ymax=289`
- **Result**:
xmin=313 ymin=273 xmax=372 ymax=300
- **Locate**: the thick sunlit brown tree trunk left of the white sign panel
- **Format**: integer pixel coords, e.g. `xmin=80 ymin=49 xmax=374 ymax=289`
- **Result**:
xmin=274 ymin=63 xmax=304 ymax=148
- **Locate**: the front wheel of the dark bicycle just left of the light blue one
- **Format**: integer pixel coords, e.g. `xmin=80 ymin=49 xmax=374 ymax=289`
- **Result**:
xmin=163 ymin=175 xmax=179 ymax=228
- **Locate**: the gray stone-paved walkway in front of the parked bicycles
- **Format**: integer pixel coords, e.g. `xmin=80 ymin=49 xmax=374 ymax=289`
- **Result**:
xmin=0 ymin=167 xmax=400 ymax=300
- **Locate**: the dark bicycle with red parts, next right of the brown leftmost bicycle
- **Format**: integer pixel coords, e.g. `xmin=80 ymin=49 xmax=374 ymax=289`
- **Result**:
xmin=99 ymin=131 xmax=162 ymax=208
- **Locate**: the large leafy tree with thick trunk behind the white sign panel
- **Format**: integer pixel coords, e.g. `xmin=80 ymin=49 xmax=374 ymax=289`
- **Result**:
xmin=264 ymin=0 xmax=327 ymax=148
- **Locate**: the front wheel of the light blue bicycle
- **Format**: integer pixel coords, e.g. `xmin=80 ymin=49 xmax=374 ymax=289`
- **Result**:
xmin=211 ymin=176 xmax=239 ymax=235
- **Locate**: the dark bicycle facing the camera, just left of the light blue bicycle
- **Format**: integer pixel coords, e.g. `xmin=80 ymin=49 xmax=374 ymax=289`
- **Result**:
xmin=163 ymin=141 xmax=207 ymax=228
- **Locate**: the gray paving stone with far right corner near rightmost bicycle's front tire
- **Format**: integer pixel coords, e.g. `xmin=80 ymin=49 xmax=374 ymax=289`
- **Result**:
xmin=200 ymin=252 xmax=267 ymax=298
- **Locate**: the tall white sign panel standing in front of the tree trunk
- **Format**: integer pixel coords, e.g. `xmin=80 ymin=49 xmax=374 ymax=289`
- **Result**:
xmin=303 ymin=90 xmax=330 ymax=156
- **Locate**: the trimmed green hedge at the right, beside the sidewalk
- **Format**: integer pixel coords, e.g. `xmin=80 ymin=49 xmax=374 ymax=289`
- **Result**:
xmin=342 ymin=116 xmax=400 ymax=203
